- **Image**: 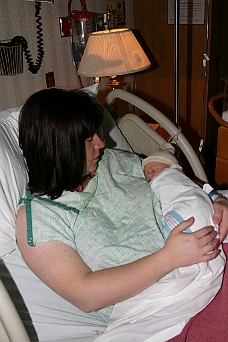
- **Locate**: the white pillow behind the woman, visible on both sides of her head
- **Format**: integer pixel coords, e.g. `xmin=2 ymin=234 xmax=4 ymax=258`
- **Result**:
xmin=0 ymin=84 xmax=132 ymax=259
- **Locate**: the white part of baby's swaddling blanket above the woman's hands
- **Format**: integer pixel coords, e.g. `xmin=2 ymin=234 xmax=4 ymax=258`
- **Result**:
xmin=150 ymin=164 xmax=214 ymax=235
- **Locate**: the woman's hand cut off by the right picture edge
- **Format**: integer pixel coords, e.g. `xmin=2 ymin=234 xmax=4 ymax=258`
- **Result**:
xmin=212 ymin=197 xmax=228 ymax=242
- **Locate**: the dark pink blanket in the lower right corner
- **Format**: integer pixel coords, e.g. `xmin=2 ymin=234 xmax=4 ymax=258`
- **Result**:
xmin=169 ymin=243 xmax=228 ymax=342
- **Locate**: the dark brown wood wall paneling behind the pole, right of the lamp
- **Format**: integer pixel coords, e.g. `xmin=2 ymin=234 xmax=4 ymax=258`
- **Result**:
xmin=134 ymin=0 xmax=210 ymax=158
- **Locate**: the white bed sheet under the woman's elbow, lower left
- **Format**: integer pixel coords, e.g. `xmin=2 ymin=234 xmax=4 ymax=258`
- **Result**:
xmin=0 ymin=251 xmax=107 ymax=342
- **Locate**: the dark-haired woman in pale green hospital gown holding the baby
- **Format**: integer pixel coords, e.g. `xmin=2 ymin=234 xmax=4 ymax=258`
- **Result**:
xmin=16 ymin=89 xmax=227 ymax=340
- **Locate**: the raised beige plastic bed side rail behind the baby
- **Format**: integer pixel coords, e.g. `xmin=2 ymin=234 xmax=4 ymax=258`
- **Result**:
xmin=104 ymin=89 xmax=207 ymax=183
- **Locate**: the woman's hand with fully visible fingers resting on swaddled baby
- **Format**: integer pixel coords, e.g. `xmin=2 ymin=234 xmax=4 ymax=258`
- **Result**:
xmin=164 ymin=217 xmax=220 ymax=268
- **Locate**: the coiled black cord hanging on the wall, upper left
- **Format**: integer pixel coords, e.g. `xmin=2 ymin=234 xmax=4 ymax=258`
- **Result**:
xmin=10 ymin=2 xmax=44 ymax=74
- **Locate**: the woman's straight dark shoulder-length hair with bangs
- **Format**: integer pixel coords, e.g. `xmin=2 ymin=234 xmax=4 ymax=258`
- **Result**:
xmin=19 ymin=88 xmax=103 ymax=199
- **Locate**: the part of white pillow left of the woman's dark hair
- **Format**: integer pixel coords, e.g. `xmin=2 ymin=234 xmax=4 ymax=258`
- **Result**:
xmin=0 ymin=111 xmax=27 ymax=258
